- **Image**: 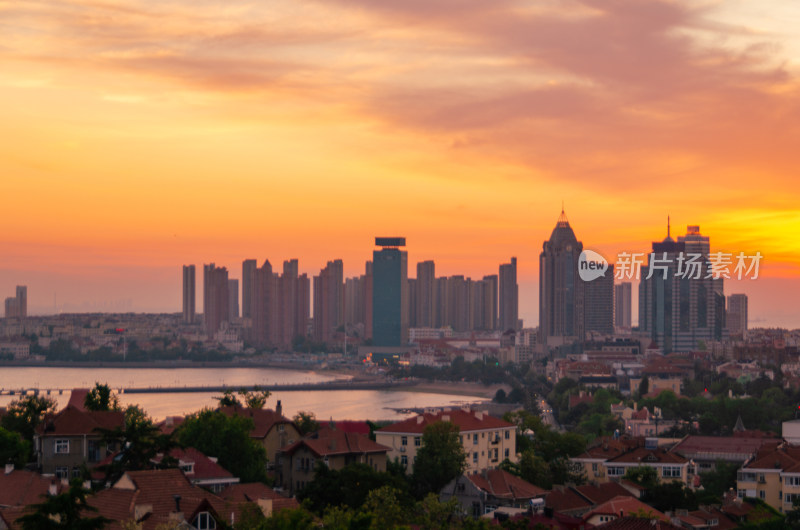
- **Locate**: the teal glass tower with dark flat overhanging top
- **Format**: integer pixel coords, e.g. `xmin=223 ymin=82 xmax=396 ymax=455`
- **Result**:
xmin=372 ymin=237 xmax=409 ymax=346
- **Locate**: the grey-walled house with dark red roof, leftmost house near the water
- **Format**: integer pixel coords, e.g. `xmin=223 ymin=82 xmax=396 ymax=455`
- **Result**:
xmin=34 ymin=405 xmax=125 ymax=478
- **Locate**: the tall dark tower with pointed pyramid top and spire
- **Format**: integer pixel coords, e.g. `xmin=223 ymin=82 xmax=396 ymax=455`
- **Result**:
xmin=540 ymin=209 xmax=584 ymax=346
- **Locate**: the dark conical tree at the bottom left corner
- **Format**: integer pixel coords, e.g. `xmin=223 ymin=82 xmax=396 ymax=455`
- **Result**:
xmin=17 ymin=480 xmax=111 ymax=530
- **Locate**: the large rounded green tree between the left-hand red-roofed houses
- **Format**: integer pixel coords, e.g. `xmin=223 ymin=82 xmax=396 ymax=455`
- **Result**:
xmin=177 ymin=409 xmax=267 ymax=482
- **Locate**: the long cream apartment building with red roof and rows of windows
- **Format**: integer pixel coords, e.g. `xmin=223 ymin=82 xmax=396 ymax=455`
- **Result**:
xmin=375 ymin=409 xmax=517 ymax=473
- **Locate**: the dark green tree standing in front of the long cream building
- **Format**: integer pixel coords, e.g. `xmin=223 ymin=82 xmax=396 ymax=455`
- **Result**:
xmin=412 ymin=421 xmax=467 ymax=497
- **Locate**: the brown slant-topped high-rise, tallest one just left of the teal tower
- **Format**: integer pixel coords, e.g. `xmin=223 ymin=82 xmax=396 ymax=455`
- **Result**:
xmin=314 ymin=259 xmax=344 ymax=342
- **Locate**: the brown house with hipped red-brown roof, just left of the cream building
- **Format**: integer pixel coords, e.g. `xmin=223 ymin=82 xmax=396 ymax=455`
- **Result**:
xmin=276 ymin=427 xmax=389 ymax=494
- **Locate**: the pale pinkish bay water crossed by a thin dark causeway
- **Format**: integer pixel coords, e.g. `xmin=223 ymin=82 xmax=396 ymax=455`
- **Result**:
xmin=0 ymin=367 xmax=480 ymax=420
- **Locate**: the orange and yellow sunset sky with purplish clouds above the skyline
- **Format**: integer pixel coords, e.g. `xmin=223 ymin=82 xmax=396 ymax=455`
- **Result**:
xmin=0 ymin=0 xmax=800 ymax=328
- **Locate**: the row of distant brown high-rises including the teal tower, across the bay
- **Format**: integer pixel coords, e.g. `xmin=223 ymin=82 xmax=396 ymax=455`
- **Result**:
xmin=182 ymin=237 xmax=522 ymax=349
